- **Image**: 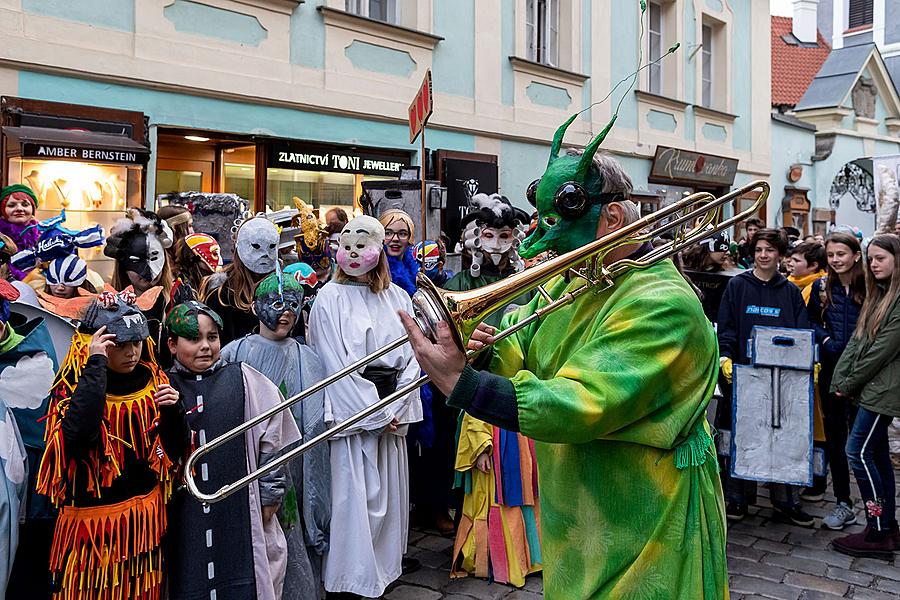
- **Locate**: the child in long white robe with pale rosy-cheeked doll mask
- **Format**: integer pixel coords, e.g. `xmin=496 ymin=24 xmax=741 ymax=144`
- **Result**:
xmin=309 ymin=216 xmax=422 ymax=598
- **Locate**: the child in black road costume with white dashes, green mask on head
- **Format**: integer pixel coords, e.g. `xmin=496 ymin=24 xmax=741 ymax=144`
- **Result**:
xmin=166 ymin=300 xmax=300 ymax=600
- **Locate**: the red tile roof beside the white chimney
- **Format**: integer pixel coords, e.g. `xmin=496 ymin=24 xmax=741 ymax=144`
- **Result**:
xmin=772 ymin=17 xmax=831 ymax=106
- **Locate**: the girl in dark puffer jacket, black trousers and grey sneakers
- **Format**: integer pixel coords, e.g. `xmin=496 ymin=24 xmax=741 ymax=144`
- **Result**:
xmin=807 ymin=232 xmax=866 ymax=529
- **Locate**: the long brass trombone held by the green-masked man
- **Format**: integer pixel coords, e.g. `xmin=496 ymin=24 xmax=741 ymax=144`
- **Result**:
xmin=185 ymin=180 xmax=769 ymax=505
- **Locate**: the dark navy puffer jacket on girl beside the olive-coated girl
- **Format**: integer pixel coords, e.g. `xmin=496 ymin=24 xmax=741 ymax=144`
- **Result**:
xmin=807 ymin=277 xmax=862 ymax=369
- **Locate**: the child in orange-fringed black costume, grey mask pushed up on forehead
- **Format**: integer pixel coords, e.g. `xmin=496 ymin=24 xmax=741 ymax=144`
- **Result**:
xmin=37 ymin=292 xmax=190 ymax=600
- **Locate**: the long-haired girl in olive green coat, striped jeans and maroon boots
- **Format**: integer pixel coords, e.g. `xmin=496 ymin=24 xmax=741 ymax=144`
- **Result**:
xmin=831 ymin=234 xmax=900 ymax=560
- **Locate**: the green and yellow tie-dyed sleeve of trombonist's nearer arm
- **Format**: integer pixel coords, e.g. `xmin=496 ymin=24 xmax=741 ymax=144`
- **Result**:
xmin=512 ymin=296 xmax=718 ymax=449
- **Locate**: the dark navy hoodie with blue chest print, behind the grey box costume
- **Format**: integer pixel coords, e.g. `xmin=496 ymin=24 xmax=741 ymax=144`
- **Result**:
xmin=717 ymin=270 xmax=809 ymax=365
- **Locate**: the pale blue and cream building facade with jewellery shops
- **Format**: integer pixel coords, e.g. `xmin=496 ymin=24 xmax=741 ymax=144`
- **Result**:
xmin=0 ymin=0 xmax=771 ymax=239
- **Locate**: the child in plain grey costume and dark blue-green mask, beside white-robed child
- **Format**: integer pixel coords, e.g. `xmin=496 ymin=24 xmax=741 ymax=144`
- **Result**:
xmin=222 ymin=272 xmax=331 ymax=600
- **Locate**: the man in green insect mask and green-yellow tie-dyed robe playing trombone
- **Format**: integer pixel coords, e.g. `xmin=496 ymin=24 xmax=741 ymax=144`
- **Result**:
xmin=401 ymin=115 xmax=728 ymax=600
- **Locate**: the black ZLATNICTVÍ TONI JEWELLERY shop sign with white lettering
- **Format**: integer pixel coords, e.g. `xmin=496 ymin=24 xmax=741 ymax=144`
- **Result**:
xmin=269 ymin=142 xmax=409 ymax=176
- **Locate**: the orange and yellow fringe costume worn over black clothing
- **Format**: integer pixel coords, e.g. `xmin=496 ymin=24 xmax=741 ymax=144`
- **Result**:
xmin=37 ymin=332 xmax=173 ymax=600
